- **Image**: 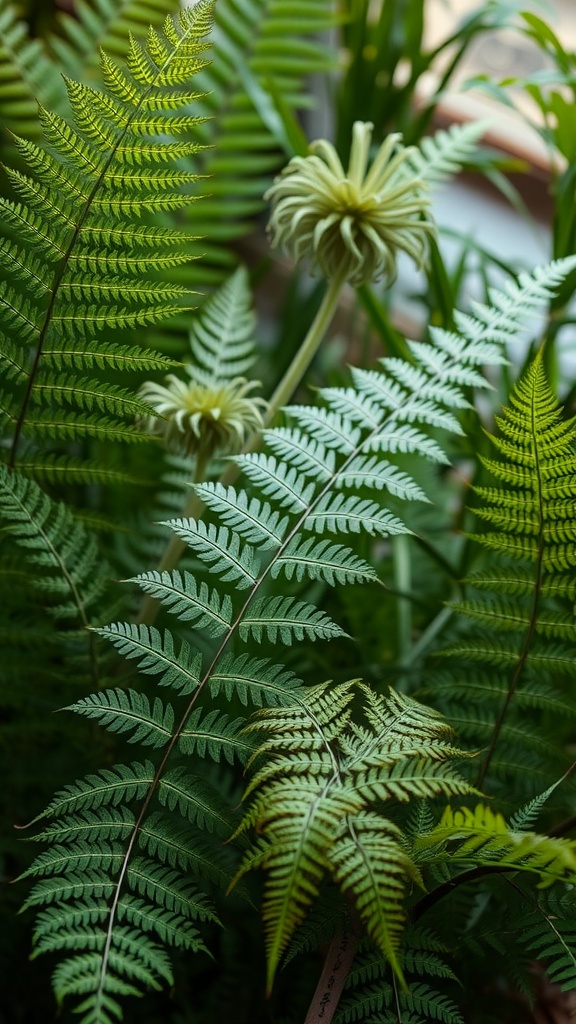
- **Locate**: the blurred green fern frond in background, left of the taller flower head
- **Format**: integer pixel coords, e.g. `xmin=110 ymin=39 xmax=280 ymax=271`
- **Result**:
xmin=157 ymin=0 xmax=337 ymax=283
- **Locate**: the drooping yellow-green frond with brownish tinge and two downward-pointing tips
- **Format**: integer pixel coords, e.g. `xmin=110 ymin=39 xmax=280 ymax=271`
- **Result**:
xmin=233 ymin=683 xmax=468 ymax=986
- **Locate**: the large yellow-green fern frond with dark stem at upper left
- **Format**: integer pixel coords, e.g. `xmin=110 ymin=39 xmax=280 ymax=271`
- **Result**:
xmin=0 ymin=0 xmax=212 ymax=481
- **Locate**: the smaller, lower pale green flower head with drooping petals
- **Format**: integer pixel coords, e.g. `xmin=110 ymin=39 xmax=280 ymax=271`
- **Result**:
xmin=140 ymin=367 xmax=266 ymax=458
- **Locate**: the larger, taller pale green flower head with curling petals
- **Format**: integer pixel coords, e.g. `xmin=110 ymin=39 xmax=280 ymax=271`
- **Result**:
xmin=265 ymin=121 xmax=435 ymax=287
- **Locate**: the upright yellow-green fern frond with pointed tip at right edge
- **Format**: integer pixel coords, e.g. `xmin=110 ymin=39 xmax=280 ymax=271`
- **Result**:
xmin=422 ymin=355 xmax=576 ymax=796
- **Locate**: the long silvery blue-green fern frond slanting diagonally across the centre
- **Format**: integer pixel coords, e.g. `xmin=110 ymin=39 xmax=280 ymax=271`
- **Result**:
xmin=17 ymin=261 xmax=572 ymax=1024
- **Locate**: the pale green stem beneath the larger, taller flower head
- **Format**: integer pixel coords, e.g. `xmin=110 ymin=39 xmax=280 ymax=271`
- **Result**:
xmin=137 ymin=274 xmax=345 ymax=626
